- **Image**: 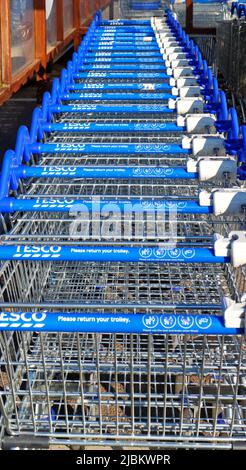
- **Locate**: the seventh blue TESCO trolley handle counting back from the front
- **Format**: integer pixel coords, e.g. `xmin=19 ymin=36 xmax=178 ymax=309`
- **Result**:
xmin=50 ymin=103 xmax=176 ymax=114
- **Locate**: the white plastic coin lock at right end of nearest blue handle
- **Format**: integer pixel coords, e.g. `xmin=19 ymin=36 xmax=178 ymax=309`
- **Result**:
xmin=222 ymin=294 xmax=246 ymax=328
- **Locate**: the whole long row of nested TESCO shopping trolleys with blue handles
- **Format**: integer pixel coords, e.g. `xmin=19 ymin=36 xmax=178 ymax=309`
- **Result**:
xmin=0 ymin=6 xmax=246 ymax=449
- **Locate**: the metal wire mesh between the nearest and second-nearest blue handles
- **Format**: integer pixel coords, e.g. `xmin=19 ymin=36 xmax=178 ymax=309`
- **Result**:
xmin=0 ymin=250 xmax=246 ymax=304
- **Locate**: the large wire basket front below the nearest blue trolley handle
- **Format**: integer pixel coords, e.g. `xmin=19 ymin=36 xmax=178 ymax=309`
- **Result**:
xmin=0 ymin=324 xmax=246 ymax=448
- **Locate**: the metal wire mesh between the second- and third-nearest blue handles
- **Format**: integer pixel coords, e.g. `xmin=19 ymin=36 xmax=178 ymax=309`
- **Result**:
xmin=1 ymin=209 xmax=245 ymax=242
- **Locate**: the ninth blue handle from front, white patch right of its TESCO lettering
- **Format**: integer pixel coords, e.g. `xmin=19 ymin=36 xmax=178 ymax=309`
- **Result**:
xmin=68 ymin=81 xmax=172 ymax=92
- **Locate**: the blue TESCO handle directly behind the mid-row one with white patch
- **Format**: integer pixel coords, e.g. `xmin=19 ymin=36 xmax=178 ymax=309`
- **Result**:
xmin=73 ymin=71 xmax=170 ymax=81
